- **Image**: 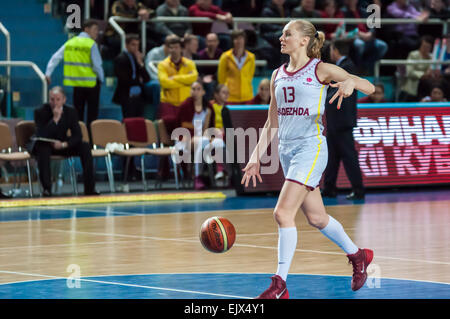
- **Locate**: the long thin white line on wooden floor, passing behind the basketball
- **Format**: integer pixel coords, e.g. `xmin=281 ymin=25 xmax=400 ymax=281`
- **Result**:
xmin=46 ymin=229 xmax=450 ymax=265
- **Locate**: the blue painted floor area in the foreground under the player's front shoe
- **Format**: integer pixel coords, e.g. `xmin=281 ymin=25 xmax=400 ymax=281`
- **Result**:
xmin=0 ymin=274 xmax=450 ymax=299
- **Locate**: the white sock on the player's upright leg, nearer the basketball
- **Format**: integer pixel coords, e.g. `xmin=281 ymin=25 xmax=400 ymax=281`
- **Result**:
xmin=277 ymin=227 xmax=297 ymax=281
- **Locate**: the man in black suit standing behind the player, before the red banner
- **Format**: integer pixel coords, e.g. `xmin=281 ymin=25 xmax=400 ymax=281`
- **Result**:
xmin=322 ymin=40 xmax=364 ymax=200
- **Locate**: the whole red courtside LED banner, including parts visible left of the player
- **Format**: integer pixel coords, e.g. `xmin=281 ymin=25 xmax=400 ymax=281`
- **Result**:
xmin=226 ymin=103 xmax=450 ymax=193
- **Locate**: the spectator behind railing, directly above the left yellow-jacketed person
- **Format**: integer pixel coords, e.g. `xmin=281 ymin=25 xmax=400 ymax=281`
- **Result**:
xmin=156 ymin=0 xmax=192 ymax=38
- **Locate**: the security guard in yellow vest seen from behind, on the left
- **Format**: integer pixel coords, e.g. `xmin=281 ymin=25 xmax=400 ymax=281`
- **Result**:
xmin=45 ymin=20 xmax=104 ymax=138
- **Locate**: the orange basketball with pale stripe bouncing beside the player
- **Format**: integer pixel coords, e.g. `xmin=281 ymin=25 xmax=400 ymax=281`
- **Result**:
xmin=200 ymin=216 xmax=236 ymax=253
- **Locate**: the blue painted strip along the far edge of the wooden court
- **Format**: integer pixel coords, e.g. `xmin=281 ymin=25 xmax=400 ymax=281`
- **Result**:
xmin=0 ymin=190 xmax=450 ymax=222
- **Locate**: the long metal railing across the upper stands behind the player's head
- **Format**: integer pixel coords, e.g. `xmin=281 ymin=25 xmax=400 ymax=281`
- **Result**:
xmin=108 ymin=16 xmax=450 ymax=52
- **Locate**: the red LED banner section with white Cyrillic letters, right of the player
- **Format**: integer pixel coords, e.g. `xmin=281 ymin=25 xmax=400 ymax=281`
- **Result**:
xmin=337 ymin=104 xmax=450 ymax=187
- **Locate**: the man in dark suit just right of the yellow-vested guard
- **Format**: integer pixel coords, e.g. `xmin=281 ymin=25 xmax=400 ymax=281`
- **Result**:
xmin=113 ymin=34 xmax=150 ymax=118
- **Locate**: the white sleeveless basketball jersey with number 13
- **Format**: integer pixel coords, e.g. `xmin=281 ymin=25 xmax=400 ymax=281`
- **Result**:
xmin=274 ymin=58 xmax=328 ymax=141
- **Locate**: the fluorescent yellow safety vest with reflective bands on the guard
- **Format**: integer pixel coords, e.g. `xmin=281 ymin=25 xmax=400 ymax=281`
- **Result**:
xmin=64 ymin=37 xmax=97 ymax=87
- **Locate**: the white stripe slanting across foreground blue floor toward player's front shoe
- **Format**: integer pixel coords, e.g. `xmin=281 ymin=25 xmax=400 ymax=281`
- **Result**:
xmin=0 ymin=270 xmax=253 ymax=299
